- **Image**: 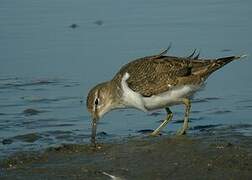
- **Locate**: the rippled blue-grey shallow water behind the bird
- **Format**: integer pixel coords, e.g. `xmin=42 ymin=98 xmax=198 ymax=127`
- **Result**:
xmin=0 ymin=0 xmax=252 ymax=157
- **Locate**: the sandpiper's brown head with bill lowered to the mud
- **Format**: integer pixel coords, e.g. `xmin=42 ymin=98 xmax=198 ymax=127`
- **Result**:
xmin=86 ymin=82 xmax=114 ymax=143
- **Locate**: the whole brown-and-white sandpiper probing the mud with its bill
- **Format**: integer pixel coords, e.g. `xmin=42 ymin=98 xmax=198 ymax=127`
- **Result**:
xmin=86 ymin=46 xmax=246 ymax=144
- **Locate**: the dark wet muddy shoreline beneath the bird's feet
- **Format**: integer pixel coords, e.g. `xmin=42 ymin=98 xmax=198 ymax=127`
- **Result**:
xmin=0 ymin=129 xmax=252 ymax=179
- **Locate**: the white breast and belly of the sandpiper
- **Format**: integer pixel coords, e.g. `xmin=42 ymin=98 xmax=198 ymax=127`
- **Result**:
xmin=121 ymin=73 xmax=200 ymax=111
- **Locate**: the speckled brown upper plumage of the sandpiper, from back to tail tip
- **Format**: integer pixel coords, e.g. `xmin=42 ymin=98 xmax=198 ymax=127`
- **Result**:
xmin=112 ymin=51 xmax=240 ymax=97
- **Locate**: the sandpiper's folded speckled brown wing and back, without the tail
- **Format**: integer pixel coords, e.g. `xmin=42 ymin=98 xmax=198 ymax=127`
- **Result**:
xmin=113 ymin=56 xmax=195 ymax=97
